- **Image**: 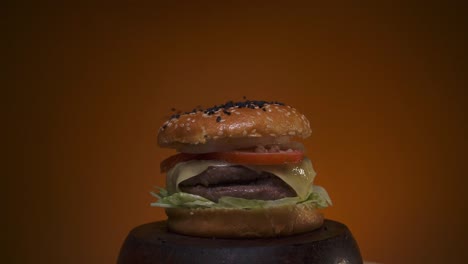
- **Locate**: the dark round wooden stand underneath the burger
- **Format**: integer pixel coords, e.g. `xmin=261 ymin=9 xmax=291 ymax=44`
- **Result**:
xmin=118 ymin=220 xmax=362 ymax=264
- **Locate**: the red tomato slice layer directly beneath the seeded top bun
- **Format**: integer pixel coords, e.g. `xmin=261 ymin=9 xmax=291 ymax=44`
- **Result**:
xmin=161 ymin=150 xmax=304 ymax=172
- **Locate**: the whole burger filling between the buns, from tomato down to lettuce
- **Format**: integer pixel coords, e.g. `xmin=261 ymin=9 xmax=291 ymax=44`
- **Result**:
xmin=152 ymin=150 xmax=331 ymax=209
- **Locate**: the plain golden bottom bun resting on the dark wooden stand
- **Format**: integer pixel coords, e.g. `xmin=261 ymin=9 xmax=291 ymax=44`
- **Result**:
xmin=166 ymin=204 xmax=323 ymax=238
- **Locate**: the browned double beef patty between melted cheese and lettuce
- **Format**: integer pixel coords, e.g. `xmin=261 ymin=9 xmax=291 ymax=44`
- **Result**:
xmin=179 ymin=165 xmax=297 ymax=202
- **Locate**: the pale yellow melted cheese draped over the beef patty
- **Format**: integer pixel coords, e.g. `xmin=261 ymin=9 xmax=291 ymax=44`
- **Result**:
xmin=166 ymin=158 xmax=316 ymax=198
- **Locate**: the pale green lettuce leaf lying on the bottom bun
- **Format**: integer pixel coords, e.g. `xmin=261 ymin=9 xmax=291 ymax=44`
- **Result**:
xmin=151 ymin=185 xmax=332 ymax=209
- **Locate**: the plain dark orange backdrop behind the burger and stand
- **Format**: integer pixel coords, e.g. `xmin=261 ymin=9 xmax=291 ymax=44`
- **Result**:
xmin=7 ymin=1 xmax=468 ymax=263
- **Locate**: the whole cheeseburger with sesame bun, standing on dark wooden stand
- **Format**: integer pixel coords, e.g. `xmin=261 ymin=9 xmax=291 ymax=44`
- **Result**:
xmin=151 ymin=100 xmax=332 ymax=238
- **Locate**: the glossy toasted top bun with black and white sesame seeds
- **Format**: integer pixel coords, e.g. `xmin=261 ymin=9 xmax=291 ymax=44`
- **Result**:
xmin=158 ymin=101 xmax=311 ymax=148
